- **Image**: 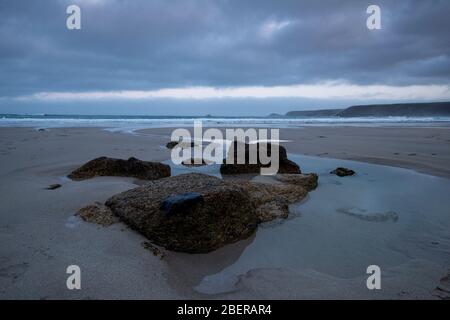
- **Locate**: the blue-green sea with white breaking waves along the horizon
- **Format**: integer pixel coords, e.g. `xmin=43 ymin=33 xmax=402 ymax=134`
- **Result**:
xmin=0 ymin=114 xmax=450 ymax=133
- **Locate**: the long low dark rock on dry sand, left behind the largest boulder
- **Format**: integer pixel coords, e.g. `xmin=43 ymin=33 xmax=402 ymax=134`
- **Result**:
xmin=68 ymin=157 xmax=170 ymax=180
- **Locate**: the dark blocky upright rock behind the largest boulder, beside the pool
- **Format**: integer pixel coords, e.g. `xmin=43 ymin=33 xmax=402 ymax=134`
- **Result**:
xmin=220 ymin=141 xmax=301 ymax=174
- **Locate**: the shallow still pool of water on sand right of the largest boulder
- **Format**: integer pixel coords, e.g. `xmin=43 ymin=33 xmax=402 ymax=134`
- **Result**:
xmin=168 ymin=154 xmax=450 ymax=294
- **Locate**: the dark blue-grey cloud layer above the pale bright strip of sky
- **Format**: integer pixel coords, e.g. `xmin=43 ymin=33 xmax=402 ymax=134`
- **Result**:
xmin=0 ymin=0 xmax=450 ymax=97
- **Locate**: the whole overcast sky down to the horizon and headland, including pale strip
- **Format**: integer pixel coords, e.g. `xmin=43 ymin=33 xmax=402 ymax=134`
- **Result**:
xmin=0 ymin=0 xmax=450 ymax=115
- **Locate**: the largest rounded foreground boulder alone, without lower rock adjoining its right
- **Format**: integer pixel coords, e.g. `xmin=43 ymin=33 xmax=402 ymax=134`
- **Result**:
xmin=106 ymin=173 xmax=258 ymax=253
